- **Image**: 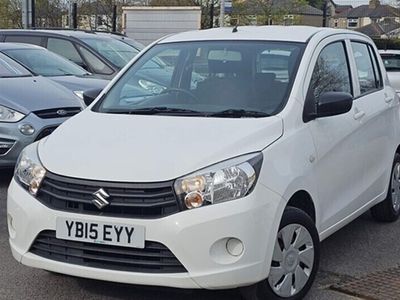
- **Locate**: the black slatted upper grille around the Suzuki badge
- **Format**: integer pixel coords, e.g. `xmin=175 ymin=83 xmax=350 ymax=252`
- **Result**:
xmin=36 ymin=172 xmax=180 ymax=219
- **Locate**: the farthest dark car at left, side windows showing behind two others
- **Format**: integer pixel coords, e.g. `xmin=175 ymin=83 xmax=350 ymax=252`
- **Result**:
xmin=0 ymin=29 xmax=140 ymax=79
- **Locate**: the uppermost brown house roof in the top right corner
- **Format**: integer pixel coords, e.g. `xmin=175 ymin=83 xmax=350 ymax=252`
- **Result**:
xmin=335 ymin=5 xmax=400 ymax=18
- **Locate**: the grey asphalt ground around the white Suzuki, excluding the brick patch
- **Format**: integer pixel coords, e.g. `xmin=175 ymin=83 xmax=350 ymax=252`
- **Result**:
xmin=0 ymin=171 xmax=400 ymax=300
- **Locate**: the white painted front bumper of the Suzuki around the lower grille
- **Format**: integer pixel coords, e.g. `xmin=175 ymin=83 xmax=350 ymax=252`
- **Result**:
xmin=7 ymin=179 xmax=284 ymax=289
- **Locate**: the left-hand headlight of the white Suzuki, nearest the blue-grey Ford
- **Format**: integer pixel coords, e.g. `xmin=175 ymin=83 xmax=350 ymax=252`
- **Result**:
xmin=14 ymin=143 xmax=46 ymax=196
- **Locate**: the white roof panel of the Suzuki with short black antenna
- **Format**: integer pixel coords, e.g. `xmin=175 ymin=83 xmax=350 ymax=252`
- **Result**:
xmin=159 ymin=25 xmax=359 ymax=43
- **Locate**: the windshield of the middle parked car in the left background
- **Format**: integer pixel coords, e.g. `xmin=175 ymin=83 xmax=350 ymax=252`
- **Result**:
xmin=3 ymin=49 xmax=88 ymax=76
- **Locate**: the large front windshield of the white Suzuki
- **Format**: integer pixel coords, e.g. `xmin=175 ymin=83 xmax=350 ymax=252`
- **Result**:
xmin=94 ymin=41 xmax=304 ymax=117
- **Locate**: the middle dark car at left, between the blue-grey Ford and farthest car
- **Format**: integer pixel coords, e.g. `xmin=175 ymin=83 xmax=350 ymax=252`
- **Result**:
xmin=0 ymin=43 xmax=109 ymax=99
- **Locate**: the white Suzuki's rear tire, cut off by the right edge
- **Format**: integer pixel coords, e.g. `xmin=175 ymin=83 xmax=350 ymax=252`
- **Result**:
xmin=371 ymin=153 xmax=400 ymax=222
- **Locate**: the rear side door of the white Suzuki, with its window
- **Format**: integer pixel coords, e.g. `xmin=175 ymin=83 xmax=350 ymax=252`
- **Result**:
xmin=350 ymin=38 xmax=398 ymax=206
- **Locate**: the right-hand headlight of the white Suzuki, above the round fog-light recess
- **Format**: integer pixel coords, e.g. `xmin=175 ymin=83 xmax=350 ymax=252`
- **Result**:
xmin=174 ymin=153 xmax=263 ymax=209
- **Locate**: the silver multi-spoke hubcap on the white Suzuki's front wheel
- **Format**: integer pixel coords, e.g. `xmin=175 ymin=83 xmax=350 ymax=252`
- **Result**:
xmin=268 ymin=224 xmax=316 ymax=297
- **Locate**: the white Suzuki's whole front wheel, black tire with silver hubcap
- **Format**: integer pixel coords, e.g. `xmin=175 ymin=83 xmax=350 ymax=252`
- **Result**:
xmin=241 ymin=207 xmax=320 ymax=300
